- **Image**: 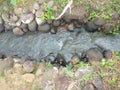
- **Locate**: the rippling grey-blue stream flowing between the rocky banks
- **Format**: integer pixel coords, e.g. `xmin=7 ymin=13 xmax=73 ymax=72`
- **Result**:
xmin=0 ymin=28 xmax=120 ymax=61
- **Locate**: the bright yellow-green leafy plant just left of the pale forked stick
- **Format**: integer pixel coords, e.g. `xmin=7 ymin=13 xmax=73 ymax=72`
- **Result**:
xmin=41 ymin=3 xmax=54 ymax=20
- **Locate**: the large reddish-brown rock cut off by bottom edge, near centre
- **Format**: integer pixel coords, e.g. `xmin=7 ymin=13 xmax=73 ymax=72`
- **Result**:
xmin=55 ymin=75 xmax=70 ymax=90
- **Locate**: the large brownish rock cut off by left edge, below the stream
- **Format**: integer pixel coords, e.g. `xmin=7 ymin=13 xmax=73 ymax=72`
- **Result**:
xmin=0 ymin=57 xmax=14 ymax=71
